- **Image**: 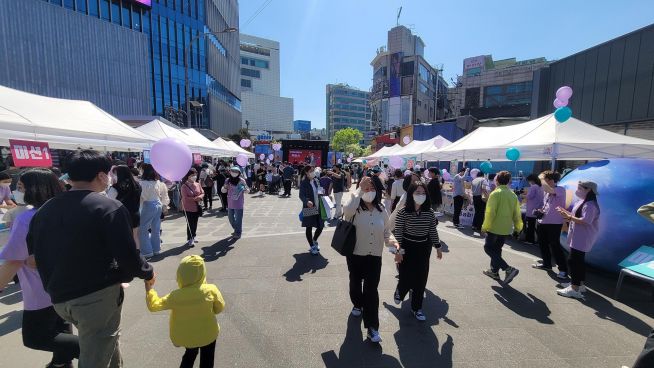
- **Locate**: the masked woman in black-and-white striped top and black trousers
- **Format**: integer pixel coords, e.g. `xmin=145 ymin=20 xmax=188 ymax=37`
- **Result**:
xmin=393 ymin=181 xmax=443 ymax=321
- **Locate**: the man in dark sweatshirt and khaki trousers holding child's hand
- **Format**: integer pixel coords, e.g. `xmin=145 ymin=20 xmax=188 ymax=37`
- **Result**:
xmin=26 ymin=150 xmax=154 ymax=367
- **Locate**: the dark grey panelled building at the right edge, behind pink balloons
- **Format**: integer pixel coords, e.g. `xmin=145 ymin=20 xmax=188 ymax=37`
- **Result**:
xmin=531 ymin=24 xmax=654 ymax=139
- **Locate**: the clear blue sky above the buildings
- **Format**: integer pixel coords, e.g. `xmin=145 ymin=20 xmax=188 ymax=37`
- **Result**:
xmin=239 ymin=0 xmax=654 ymax=128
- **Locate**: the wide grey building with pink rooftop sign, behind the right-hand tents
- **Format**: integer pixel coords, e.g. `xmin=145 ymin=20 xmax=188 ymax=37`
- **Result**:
xmin=449 ymin=55 xmax=547 ymax=119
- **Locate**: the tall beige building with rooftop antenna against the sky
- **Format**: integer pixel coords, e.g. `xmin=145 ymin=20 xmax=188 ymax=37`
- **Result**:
xmin=370 ymin=26 xmax=447 ymax=132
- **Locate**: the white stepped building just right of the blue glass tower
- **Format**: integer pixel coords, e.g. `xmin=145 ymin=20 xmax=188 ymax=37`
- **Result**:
xmin=240 ymin=34 xmax=293 ymax=133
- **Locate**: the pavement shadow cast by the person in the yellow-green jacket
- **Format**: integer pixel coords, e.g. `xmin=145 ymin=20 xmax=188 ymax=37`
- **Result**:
xmin=491 ymin=285 xmax=554 ymax=325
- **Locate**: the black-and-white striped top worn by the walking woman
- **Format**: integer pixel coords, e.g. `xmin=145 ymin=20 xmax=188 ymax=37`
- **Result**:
xmin=393 ymin=207 xmax=441 ymax=248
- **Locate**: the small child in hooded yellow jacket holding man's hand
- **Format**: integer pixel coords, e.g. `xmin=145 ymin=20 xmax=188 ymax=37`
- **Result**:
xmin=145 ymin=255 xmax=225 ymax=368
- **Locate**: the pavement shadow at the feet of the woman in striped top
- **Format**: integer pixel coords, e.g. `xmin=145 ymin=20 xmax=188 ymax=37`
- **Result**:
xmin=384 ymin=290 xmax=459 ymax=368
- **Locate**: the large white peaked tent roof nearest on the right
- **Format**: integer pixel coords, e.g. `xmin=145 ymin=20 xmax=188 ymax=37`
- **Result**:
xmin=423 ymin=114 xmax=654 ymax=161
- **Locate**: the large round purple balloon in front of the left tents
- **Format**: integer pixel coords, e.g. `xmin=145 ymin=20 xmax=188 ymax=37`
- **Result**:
xmin=150 ymin=138 xmax=193 ymax=181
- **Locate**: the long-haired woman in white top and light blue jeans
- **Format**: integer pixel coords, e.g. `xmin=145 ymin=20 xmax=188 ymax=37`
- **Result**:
xmin=138 ymin=164 xmax=163 ymax=258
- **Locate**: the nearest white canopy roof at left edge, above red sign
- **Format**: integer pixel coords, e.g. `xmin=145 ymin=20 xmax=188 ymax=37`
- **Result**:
xmin=0 ymin=86 xmax=156 ymax=152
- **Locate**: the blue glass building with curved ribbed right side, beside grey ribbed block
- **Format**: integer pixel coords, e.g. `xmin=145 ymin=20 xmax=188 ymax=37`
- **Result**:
xmin=36 ymin=0 xmax=241 ymax=134
